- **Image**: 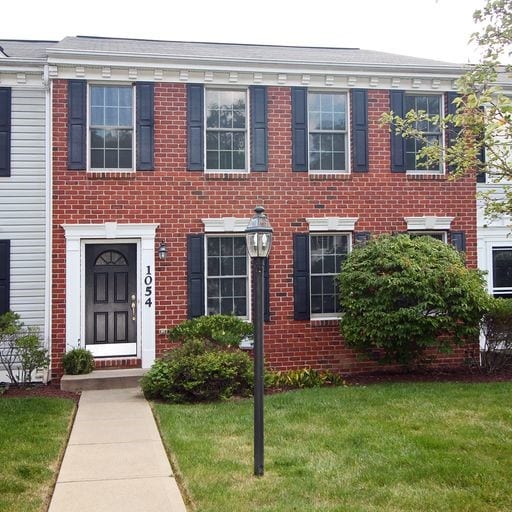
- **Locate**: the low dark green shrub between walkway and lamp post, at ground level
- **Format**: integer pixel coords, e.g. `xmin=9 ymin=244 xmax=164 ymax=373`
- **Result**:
xmin=141 ymin=340 xmax=253 ymax=403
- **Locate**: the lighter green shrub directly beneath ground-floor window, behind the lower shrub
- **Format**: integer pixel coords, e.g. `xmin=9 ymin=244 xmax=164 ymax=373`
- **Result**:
xmin=167 ymin=315 xmax=253 ymax=347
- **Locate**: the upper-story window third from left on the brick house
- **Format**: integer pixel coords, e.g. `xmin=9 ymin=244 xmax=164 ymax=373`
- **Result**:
xmin=308 ymin=92 xmax=348 ymax=172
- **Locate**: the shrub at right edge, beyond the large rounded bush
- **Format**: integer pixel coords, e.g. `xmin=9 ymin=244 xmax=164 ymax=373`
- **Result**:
xmin=482 ymin=297 xmax=512 ymax=373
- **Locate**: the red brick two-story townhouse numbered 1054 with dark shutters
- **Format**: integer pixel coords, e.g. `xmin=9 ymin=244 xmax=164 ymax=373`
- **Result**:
xmin=41 ymin=37 xmax=476 ymax=378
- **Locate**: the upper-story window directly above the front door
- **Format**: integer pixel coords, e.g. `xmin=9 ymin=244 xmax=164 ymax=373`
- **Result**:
xmin=89 ymin=85 xmax=135 ymax=170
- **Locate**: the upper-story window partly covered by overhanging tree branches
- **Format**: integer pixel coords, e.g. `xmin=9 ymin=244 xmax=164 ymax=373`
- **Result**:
xmin=404 ymin=94 xmax=442 ymax=172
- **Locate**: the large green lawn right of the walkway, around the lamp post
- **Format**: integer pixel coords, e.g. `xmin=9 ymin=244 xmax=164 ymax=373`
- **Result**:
xmin=154 ymin=382 xmax=512 ymax=512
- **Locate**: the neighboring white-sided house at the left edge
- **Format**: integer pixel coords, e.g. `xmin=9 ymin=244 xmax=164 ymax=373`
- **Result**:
xmin=0 ymin=40 xmax=53 ymax=381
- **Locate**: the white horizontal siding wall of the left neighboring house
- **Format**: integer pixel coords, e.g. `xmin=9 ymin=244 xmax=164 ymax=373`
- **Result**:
xmin=0 ymin=87 xmax=46 ymax=333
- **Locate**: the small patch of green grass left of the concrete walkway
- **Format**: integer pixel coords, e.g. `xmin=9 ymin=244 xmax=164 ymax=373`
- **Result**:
xmin=0 ymin=398 xmax=75 ymax=512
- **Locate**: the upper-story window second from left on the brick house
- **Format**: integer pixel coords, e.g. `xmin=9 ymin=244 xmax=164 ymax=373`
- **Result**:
xmin=206 ymin=89 xmax=248 ymax=171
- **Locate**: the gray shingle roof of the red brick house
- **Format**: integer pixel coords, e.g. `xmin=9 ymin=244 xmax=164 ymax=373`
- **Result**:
xmin=53 ymin=36 xmax=460 ymax=68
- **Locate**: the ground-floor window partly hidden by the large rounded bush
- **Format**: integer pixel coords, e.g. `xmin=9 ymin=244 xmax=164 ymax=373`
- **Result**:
xmin=309 ymin=234 xmax=350 ymax=317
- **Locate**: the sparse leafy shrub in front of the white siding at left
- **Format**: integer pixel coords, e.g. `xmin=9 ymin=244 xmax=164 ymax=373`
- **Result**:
xmin=0 ymin=311 xmax=50 ymax=384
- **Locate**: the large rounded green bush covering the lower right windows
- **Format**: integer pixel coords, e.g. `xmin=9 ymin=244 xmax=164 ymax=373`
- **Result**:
xmin=339 ymin=235 xmax=488 ymax=364
